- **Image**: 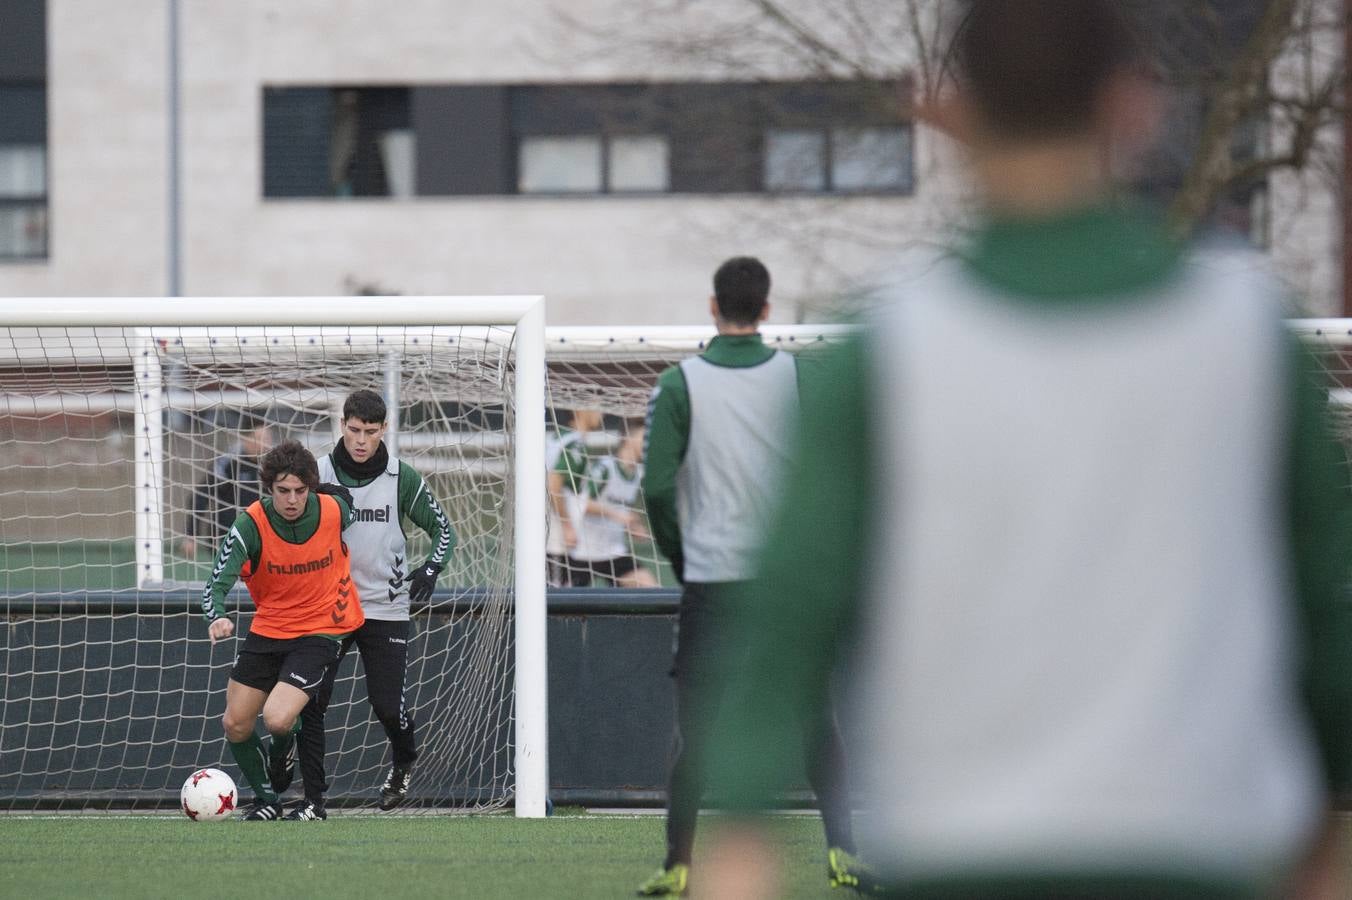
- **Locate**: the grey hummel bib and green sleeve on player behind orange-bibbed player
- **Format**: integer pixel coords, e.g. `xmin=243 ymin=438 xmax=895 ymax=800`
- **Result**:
xmin=319 ymin=453 xmax=456 ymax=622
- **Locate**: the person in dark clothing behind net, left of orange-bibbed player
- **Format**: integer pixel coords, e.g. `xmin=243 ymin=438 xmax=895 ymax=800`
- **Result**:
xmin=178 ymin=414 xmax=273 ymax=559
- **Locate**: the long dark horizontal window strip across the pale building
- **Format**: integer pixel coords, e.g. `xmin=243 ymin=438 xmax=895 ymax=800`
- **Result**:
xmin=262 ymin=80 xmax=915 ymax=197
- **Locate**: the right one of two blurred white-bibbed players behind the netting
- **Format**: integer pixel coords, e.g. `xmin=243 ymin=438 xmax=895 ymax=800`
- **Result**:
xmin=571 ymin=422 xmax=657 ymax=588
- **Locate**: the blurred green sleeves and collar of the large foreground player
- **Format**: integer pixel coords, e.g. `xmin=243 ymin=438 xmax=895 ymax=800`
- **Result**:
xmin=707 ymin=214 xmax=1352 ymax=896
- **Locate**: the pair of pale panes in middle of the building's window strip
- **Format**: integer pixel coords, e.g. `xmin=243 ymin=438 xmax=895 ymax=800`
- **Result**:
xmin=516 ymin=135 xmax=669 ymax=193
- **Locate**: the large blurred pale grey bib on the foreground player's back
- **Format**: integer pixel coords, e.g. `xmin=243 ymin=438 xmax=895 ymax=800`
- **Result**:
xmin=860 ymin=245 xmax=1322 ymax=877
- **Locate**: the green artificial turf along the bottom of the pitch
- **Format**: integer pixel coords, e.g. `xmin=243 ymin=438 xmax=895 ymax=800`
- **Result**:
xmin=0 ymin=814 xmax=853 ymax=900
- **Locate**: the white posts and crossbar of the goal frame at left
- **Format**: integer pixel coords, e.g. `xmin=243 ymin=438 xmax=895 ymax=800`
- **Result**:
xmin=0 ymin=296 xmax=549 ymax=818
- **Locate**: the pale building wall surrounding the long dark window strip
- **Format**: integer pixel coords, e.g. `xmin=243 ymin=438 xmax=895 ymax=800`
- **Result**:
xmin=0 ymin=0 xmax=962 ymax=324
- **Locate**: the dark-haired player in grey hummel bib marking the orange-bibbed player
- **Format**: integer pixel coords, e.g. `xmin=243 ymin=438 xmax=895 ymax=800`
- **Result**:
xmin=300 ymin=391 xmax=456 ymax=809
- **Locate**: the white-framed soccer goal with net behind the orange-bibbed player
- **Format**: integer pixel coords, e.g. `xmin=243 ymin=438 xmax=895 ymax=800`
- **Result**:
xmin=0 ymin=297 xmax=548 ymax=816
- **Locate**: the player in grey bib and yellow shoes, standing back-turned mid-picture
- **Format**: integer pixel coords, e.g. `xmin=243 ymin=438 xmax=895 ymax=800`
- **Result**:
xmin=638 ymin=257 xmax=863 ymax=896
